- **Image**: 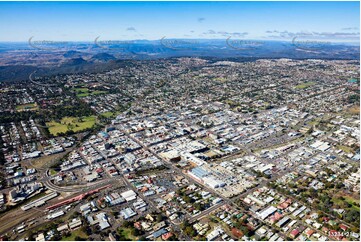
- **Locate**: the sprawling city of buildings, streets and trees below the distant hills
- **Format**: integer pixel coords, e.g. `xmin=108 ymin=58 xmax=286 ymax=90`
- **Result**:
xmin=0 ymin=0 xmax=360 ymax=241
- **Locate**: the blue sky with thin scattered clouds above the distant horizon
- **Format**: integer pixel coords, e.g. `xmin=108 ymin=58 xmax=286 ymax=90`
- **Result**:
xmin=0 ymin=2 xmax=360 ymax=42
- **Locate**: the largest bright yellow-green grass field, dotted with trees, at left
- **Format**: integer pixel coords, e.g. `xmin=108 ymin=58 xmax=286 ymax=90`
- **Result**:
xmin=46 ymin=116 xmax=96 ymax=135
